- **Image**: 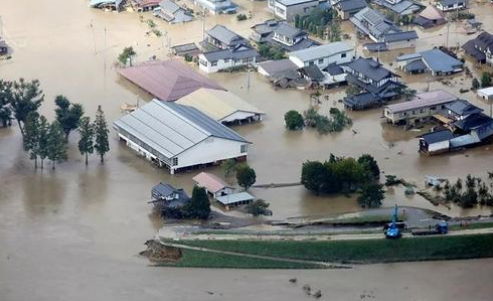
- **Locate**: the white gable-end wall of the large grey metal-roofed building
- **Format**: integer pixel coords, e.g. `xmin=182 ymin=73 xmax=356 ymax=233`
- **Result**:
xmin=173 ymin=137 xmax=247 ymax=168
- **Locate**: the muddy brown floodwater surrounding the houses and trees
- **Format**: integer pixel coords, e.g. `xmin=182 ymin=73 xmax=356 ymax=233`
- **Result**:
xmin=0 ymin=0 xmax=493 ymax=301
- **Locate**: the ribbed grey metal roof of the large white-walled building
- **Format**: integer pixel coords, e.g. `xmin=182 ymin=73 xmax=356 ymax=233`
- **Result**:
xmin=114 ymin=99 xmax=248 ymax=158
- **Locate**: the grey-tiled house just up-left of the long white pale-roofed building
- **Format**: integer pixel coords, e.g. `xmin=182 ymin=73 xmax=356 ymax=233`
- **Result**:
xmin=250 ymin=20 xmax=320 ymax=52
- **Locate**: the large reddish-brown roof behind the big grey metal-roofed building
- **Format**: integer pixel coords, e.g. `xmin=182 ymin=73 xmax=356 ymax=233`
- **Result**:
xmin=118 ymin=60 xmax=225 ymax=101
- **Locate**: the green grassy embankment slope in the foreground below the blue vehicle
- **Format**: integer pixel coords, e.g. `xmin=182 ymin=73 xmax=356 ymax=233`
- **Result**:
xmin=164 ymin=234 xmax=493 ymax=268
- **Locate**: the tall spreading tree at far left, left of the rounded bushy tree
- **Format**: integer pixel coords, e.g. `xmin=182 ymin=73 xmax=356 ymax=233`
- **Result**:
xmin=10 ymin=78 xmax=44 ymax=136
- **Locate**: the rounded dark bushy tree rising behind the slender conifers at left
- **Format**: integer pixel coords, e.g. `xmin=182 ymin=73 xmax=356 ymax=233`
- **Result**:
xmin=55 ymin=95 xmax=84 ymax=140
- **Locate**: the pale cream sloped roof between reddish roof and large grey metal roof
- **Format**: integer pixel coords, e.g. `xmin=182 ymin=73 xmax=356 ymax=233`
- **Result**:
xmin=176 ymin=89 xmax=264 ymax=121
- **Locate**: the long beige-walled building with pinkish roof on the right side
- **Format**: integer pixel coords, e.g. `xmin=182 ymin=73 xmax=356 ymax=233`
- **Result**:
xmin=383 ymin=90 xmax=458 ymax=124
